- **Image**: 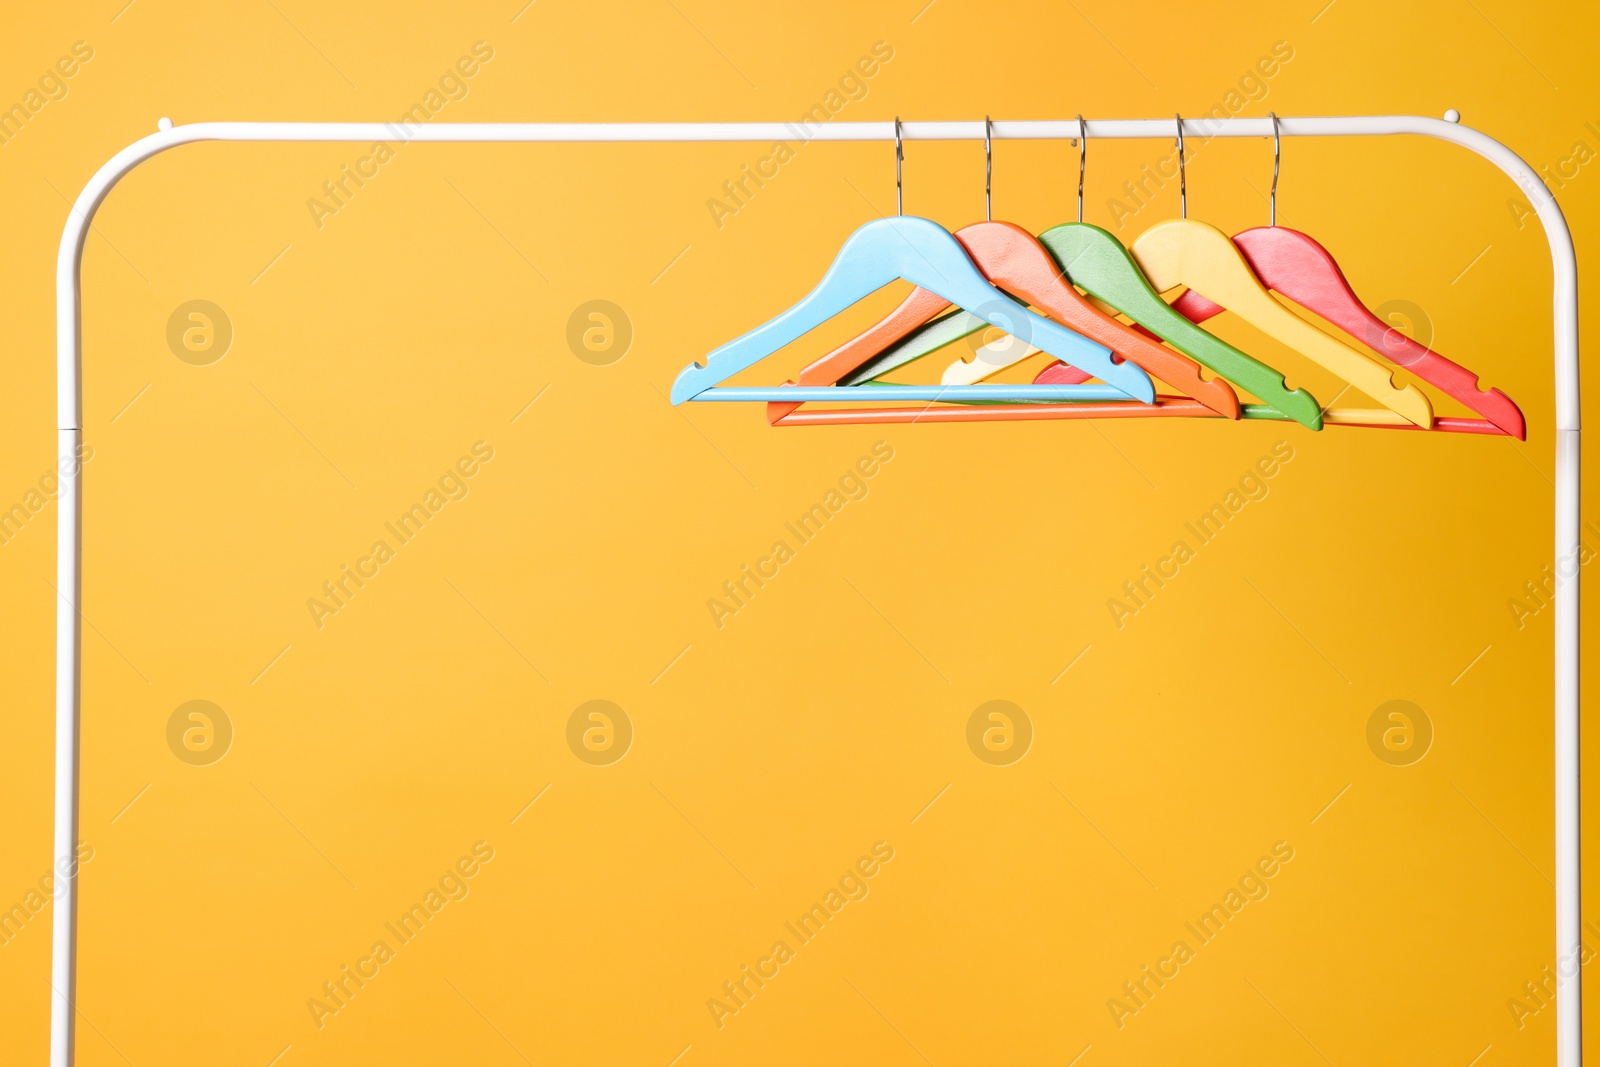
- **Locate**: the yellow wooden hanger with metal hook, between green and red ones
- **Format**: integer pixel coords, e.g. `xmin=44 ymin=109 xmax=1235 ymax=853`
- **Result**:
xmin=1131 ymin=118 xmax=1434 ymax=429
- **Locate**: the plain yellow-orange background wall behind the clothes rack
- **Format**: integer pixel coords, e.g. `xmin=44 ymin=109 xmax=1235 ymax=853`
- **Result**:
xmin=0 ymin=0 xmax=1600 ymax=1067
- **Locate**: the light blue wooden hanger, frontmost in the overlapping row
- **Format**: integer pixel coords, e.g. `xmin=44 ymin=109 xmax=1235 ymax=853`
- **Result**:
xmin=672 ymin=214 xmax=1155 ymax=405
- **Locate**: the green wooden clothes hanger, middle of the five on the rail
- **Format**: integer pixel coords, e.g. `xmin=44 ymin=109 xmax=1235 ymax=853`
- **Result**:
xmin=840 ymin=222 xmax=1322 ymax=430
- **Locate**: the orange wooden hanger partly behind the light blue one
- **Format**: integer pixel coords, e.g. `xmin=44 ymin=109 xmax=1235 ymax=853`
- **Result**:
xmin=766 ymin=222 xmax=1240 ymax=426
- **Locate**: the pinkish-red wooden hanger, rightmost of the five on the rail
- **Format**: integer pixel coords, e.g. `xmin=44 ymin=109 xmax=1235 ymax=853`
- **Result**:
xmin=1173 ymin=226 xmax=1528 ymax=440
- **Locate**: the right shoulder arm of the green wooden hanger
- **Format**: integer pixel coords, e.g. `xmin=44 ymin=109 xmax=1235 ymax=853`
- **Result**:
xmin=1038 ymin=222 xmax=1322 ymax=430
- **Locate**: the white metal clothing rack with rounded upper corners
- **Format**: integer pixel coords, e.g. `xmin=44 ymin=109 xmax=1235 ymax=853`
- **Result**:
xmin=50 ymin=115 xmax=1582 ymax=1067
